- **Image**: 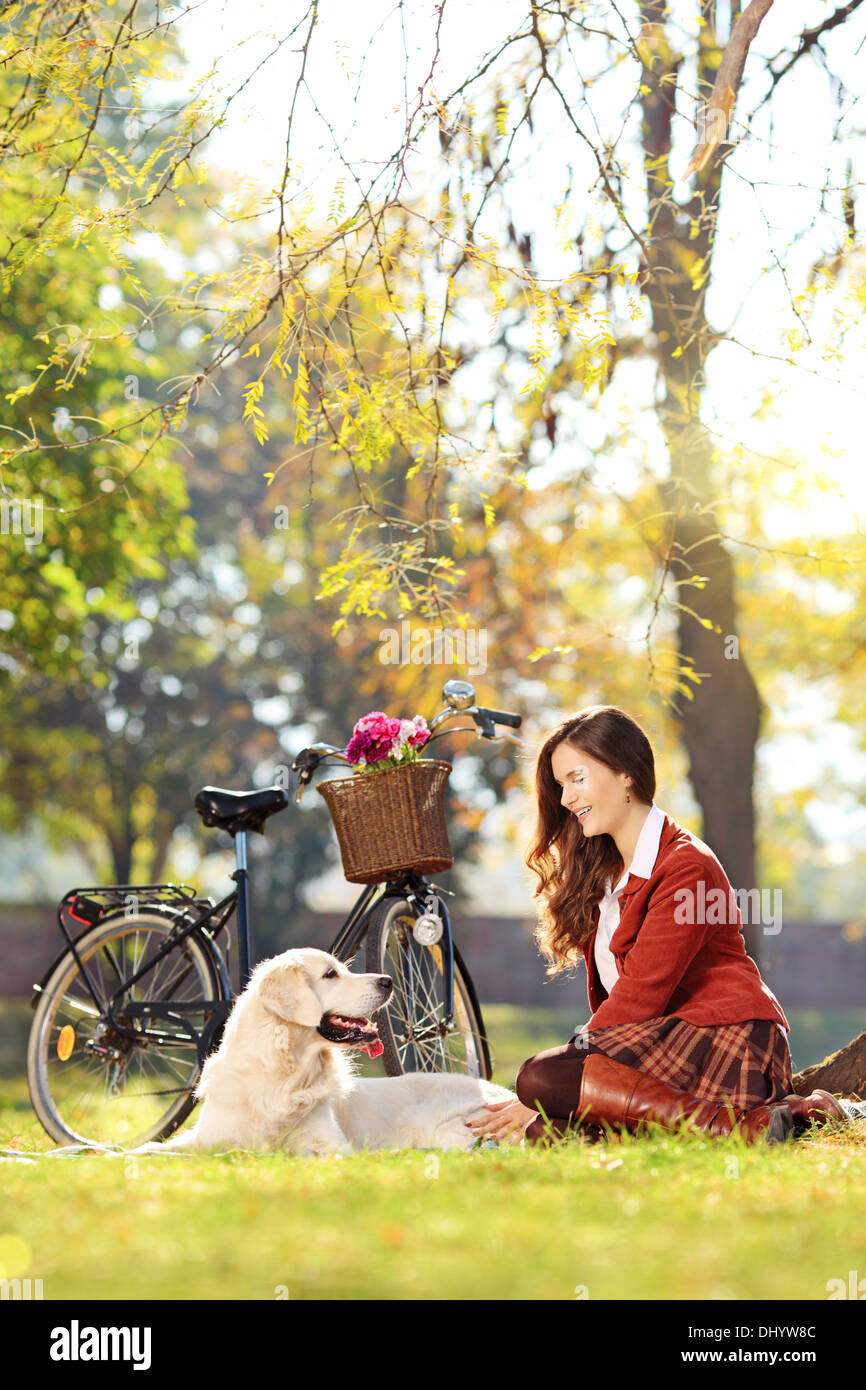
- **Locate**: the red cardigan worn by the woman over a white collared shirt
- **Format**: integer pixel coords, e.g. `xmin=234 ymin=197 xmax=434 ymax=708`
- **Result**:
xmin=582 ymin=815 xmax=790 ymax=1031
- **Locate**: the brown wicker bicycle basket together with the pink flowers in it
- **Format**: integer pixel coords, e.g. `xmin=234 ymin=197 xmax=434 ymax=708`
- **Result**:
xmin=316 ymin=710 xmax=455 ymax=883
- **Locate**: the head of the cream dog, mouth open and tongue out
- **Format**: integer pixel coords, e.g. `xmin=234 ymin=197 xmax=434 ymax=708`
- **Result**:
xmin=250 ymin=948 xmax=393 ymax=1056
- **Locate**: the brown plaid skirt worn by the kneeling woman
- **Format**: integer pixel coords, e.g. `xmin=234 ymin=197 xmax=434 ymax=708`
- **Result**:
xmin=574 ymin=1013 xmax=794 ymax=1111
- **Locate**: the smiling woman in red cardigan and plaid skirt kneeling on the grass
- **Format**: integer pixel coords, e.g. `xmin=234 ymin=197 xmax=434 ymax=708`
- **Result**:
xmin=470 ymin=705 xmax=848 ymax=1144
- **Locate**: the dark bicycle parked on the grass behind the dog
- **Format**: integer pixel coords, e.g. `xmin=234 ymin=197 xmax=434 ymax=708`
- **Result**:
xmin=26 ymin=680 xmax=523 ymax=1148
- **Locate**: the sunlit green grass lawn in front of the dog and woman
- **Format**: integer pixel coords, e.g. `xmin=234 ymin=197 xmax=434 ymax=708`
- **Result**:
xmin=0 ymin=1006 xmax=866 ymax=1301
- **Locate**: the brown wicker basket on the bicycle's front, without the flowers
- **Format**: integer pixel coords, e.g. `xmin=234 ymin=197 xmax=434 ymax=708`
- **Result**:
xmin=316 ymin=758 xmax=455 ymax=883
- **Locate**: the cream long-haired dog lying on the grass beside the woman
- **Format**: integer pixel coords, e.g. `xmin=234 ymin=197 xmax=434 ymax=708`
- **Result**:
xmin=126 ymin=948 xmax=516 ymax=1154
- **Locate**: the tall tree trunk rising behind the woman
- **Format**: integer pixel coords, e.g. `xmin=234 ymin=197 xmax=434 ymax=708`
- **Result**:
xmin=641 ymin=0 xmax=762 ymax=967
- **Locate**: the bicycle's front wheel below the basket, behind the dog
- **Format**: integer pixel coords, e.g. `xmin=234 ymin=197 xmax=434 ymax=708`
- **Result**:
xmin=366 ymin=898 xmax=492 ymax=1080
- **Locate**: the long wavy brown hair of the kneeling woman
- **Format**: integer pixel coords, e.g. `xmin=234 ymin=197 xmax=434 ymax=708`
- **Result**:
xmin=525 ymin=705 xmax=656 ymax=976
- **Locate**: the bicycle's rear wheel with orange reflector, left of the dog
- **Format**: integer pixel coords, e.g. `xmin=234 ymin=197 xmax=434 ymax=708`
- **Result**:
xmin=26 ymin=909 xmax=227 ymax=1148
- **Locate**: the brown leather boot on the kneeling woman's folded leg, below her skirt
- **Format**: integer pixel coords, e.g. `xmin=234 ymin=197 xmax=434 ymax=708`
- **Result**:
xmin=575 ymin=1052 xmax=794 ymax=1144
